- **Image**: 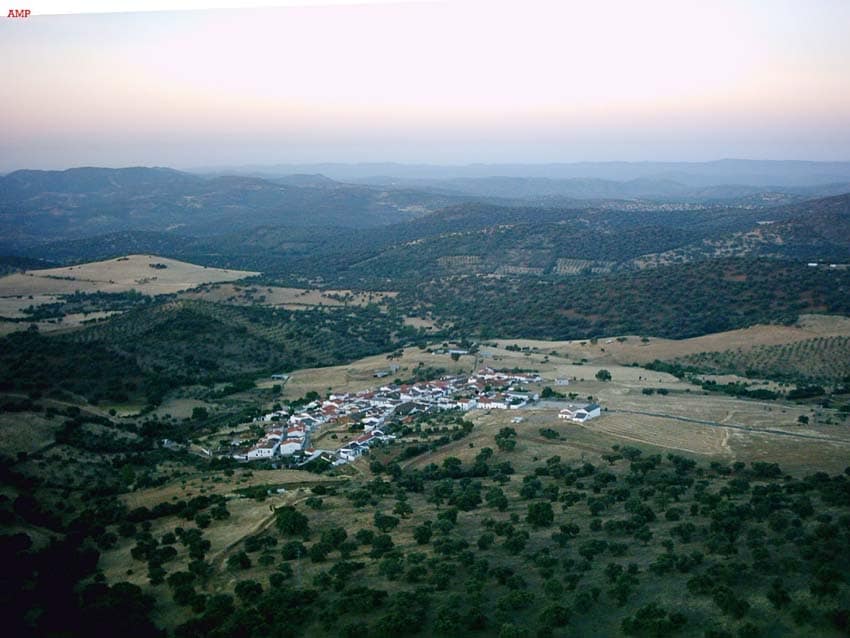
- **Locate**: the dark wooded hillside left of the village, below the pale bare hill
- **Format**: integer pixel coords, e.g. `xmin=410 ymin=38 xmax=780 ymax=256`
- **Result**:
xmin=0 ymin=300 xmax=419 ymax=405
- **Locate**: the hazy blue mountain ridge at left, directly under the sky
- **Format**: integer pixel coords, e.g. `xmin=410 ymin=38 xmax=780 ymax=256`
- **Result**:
xmin=0 ymin=168 xmax=469 ymax=248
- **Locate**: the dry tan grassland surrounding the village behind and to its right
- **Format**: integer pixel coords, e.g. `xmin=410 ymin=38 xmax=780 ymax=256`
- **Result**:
xmin=284 ymin=341 xmax=850 ymax=472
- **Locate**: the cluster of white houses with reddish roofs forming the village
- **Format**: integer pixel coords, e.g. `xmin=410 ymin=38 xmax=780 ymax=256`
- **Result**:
xmin=225 ymin=368 xmax=601 ymax=465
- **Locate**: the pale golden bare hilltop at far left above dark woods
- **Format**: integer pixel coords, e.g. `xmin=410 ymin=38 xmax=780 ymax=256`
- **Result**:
xmin=0 ymin=255 xmax=258 ymax=297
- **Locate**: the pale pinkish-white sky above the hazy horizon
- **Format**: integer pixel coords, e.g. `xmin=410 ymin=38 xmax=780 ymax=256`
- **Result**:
xmin=0 ymin=0 xmax=850 ymax=171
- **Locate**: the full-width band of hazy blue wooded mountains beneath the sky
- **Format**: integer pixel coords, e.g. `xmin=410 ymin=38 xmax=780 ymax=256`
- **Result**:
xmin=0 ymin=168 xmax=850 ymax=286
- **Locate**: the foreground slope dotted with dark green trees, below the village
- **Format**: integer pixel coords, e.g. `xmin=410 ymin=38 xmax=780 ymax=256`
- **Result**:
xmin=8 ymin=428 xmax=850 ymax=637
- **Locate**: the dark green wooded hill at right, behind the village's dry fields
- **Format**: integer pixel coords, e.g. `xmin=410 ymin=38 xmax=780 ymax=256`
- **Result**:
xmin=396 ymin=259 xmax=850 ymax=339
